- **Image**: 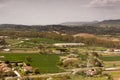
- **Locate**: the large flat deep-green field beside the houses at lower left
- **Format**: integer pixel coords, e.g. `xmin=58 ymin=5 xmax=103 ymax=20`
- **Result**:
xmin=0 ymin=53 xmax=63 ymax=73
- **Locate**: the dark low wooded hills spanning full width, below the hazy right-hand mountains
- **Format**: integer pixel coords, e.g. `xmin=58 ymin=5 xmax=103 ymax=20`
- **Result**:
xmin=0 ymin=24 xmax=120 ymax=35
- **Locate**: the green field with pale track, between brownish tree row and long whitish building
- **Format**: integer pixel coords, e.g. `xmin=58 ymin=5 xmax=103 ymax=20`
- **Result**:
xmin=6 ymin=38 xmax=62 ymax=48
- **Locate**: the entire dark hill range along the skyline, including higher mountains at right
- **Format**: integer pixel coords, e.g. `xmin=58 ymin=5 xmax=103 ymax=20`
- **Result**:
xmin=0 ymin=19 xmax=120 ymax=35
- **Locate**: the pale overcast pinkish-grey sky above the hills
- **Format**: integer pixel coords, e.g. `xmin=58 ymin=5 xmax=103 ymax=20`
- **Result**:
xmin=0 ymin=0 xmax=120 ymax=25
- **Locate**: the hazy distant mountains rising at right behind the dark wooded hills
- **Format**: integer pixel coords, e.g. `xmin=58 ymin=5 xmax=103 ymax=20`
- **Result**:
xmin=61 ymin=19 xmax=120 ymax=27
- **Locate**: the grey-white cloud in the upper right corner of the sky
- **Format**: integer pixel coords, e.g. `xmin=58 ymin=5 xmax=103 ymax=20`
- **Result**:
xmin=88 ymin=0 xmax=120 ymax=8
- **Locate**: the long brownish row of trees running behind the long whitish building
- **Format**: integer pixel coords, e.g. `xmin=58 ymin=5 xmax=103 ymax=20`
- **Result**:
xmin=0 ymin=31 xmax=120 ymax=48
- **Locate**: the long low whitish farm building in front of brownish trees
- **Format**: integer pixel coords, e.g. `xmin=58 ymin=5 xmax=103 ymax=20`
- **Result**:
xmin=54 ymin=43 xmax=85 ymax=47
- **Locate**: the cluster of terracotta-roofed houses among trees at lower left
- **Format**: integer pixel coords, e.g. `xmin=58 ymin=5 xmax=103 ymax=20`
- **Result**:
xmin=0 ymin=56 xmax=33 ymax=77
